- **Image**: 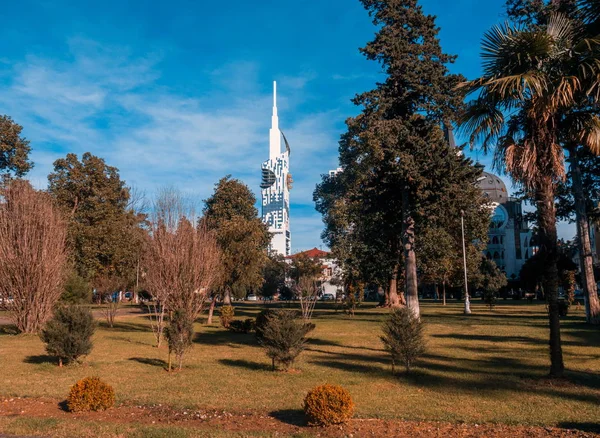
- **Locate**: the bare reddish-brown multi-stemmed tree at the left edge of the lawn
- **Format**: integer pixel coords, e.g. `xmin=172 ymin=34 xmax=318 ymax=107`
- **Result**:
xmin=0 ymin=180 xmax=67 ymax=333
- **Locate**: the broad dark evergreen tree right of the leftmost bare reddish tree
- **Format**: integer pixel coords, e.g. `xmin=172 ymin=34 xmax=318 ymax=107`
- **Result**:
xmin=48 ymin=152 xmax=145 ymax=287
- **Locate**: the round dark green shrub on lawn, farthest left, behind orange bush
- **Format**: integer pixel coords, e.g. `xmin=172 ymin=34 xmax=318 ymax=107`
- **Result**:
xmin=40 ymin=305 xmax=96 ymax=366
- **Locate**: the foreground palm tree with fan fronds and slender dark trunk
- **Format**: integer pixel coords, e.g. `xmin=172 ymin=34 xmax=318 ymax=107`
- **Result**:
xmin=461 ymin=14 xmax=600 ymax=377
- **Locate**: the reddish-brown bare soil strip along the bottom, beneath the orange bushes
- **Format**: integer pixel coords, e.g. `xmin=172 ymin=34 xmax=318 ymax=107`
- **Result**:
xmin=0 ymin=398 xmax=600 ymax=438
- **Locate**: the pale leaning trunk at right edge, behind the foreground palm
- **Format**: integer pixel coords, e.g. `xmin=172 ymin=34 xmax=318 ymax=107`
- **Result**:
xmin=569 ymin=147 xmax=600 ymax=325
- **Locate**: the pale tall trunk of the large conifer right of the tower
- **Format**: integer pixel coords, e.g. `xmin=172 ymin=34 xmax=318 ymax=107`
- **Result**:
xmin=402 ymin=190 xmax=421 ymax=318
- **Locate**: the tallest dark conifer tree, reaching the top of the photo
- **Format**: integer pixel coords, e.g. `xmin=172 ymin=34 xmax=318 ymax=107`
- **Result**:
xmin=315 ymin=0 xmax=487 ymax=316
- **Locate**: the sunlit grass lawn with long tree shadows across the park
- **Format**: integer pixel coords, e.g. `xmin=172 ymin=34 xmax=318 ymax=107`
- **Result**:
xmin=0 ymin=301 xmax=600 ymax=436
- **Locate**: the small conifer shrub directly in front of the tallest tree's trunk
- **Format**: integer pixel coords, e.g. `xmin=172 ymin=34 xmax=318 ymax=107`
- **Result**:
xmin=381 ymin=307 xmax=425 ymax=373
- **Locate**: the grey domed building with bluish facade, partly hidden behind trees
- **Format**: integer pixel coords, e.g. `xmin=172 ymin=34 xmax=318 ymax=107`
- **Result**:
xmin=478 ymin=172 xmax=534 ymax=280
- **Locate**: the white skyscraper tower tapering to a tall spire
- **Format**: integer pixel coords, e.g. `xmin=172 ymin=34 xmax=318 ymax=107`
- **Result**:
xmin=260 ymin=82 xmax=292 ymax=256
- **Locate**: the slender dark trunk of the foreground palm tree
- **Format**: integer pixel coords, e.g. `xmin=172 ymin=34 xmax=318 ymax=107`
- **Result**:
xmin=536 ymin=178 xmax=565 ymax=377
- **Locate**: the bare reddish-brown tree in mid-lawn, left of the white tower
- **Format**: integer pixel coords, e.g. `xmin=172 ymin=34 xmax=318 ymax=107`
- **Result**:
xmin=144 ymin=189 xmax=221 ymax=346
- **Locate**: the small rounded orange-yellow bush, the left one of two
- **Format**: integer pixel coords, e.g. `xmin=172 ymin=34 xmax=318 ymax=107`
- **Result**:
xmin=67 ymin=377 xmax=115 ymax=412
